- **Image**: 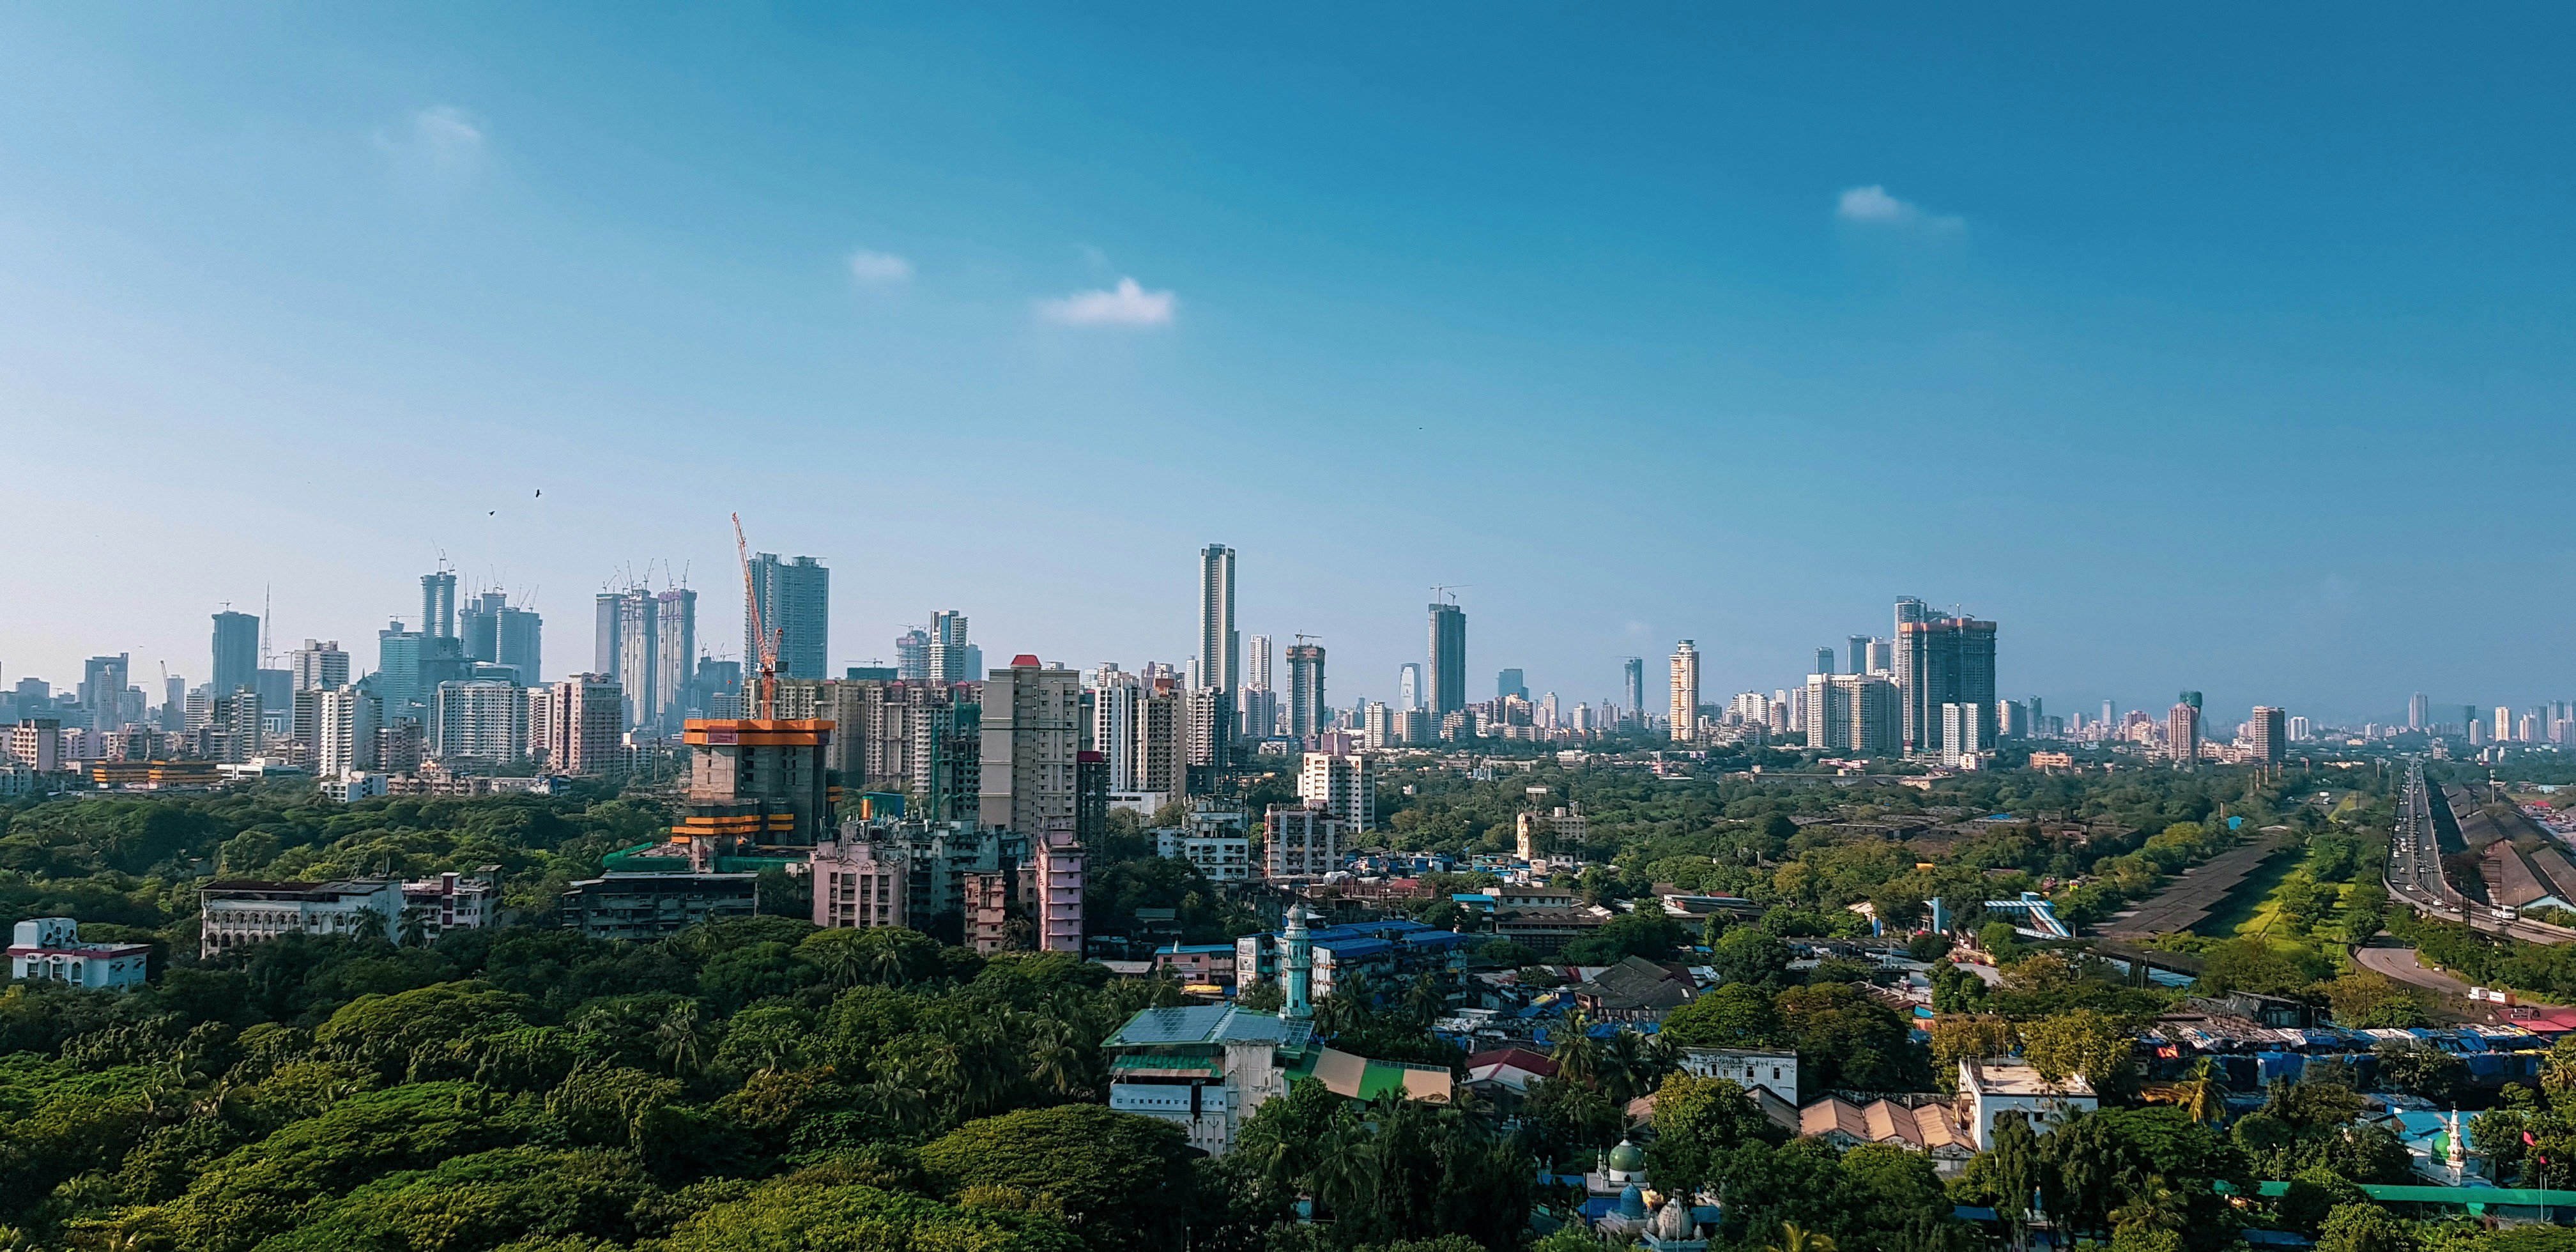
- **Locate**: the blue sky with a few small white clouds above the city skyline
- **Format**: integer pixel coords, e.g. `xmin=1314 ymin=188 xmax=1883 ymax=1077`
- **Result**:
xmin=0 ymin=5 xmax=2576 ymax=721
